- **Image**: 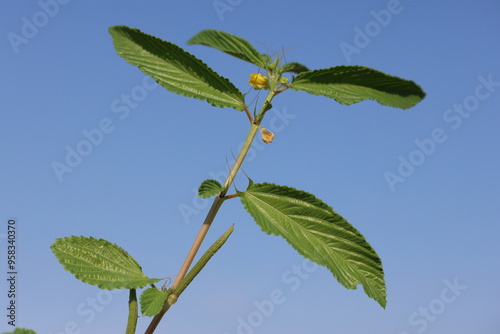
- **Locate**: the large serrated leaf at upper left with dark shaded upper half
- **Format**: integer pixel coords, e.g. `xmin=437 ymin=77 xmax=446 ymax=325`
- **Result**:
xmin=109 ymin=26 xmax=244 ymax=110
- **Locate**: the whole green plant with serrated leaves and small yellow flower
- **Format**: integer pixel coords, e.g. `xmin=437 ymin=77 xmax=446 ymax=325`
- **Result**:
xmin=47 ymin=26 xmax=425 ymax=333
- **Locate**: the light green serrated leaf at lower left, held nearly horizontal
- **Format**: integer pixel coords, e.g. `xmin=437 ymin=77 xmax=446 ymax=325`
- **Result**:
xmin=50 ymin=236 xmax=160 ymax=290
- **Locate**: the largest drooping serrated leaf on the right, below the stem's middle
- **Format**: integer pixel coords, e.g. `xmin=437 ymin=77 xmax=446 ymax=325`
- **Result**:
xmin=239 ymin=183 xmax=386 ymax=307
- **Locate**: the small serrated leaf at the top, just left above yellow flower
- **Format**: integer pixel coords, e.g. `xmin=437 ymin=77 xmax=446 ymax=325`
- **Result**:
xmin=187 ymin=29 xmax=266 ymax=68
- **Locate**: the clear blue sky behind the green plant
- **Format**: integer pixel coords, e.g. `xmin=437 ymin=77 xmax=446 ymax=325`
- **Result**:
xmin=0 ymin=0 xmax=500 ymax=334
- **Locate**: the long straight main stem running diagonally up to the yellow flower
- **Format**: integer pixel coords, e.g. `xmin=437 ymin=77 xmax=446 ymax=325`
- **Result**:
xmin=145 ymin=91 xmax=275 ymax=334
